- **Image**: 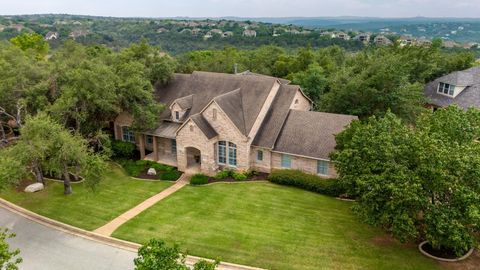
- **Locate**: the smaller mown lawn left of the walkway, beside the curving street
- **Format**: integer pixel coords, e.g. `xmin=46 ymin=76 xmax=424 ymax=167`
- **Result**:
xmin=0 ymin=164 xmax=172 ymax=230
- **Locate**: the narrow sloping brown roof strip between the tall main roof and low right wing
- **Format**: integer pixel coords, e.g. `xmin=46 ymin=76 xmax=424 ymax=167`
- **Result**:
xmin=252 ymin=85 xmax=298 ymax=148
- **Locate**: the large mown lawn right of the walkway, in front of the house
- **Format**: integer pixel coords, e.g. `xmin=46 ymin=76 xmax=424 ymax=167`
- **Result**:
xmin=114 ymin=183 xmax=440 ymax=270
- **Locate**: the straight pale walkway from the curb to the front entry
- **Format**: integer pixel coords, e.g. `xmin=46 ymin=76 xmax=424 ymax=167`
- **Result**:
xmin=94 ymin=174 xmax=189 ymax=236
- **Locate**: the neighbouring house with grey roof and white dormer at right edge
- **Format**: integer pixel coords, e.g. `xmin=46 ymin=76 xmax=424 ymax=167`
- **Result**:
xmin=424 ymin=67 xmax=480 ymax=109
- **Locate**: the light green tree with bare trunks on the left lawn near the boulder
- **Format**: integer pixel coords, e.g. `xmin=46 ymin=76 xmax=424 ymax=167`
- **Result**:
xmin=0 ymin=113 xmax=106 ymax=195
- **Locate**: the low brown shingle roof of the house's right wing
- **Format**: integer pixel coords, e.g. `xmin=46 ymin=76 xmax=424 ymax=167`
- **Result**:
xmin=273 ymin=110 xmax=358 ymax=159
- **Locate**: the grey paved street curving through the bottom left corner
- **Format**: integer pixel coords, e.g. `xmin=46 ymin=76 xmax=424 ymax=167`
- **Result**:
xmin=0 ymin=208 xmax=136 ymax=270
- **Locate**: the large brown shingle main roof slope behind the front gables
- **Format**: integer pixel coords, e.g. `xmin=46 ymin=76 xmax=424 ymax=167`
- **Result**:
xmin=155 ymin=71 xmax=278 ymax=135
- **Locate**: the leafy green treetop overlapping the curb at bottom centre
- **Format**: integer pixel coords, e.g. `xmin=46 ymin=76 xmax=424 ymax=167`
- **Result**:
xmin=133 ymin=239 xmax=219 ymax=270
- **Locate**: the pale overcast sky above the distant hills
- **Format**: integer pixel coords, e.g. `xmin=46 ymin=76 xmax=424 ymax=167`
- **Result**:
xmin=0 ymin=0 xmax=480 ymax=18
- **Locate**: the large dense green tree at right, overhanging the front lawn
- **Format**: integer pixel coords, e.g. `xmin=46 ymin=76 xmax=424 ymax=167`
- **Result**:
xmin=331 ymin=106 xmax=480 ymax=255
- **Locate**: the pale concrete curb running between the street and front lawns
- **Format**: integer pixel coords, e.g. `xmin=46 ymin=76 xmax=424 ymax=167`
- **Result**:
xmin=0 ymin=198 xmax=265 ymax=270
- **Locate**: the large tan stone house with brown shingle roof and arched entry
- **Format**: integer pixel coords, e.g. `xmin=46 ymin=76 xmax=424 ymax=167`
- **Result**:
xmin=113 ymin=71 xmax=357 ymax=177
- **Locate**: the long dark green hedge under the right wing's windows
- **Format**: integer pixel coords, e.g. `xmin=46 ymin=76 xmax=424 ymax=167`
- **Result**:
xmin=268 ymin=170 xmax=345 ymax=197
